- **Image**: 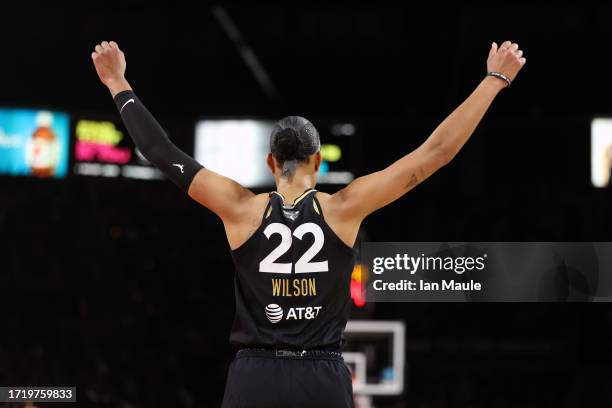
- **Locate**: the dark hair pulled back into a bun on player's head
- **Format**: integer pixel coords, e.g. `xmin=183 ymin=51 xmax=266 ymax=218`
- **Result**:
xmin=270 ymin=116 xmax=321 ymax=176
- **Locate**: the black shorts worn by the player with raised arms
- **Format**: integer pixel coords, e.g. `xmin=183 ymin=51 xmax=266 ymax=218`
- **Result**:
xmin=222 ymin=351 xmax=354 ymax=408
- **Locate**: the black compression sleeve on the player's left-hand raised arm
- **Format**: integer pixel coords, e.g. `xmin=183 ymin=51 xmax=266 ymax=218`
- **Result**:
xmin=115 ymin=91 xmax=203 ymax=192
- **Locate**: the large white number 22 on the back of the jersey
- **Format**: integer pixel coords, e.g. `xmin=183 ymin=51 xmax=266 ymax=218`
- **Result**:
xmin=259 ymin=222 xmax=328 ymax=274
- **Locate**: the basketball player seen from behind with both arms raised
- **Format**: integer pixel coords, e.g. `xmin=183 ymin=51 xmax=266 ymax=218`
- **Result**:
xmin=92 ymin=41 xmax=525 ymax=408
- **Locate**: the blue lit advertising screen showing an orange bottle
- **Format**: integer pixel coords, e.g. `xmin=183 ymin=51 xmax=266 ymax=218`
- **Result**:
xmin=0 ymin=109 xmax=69 ymax=178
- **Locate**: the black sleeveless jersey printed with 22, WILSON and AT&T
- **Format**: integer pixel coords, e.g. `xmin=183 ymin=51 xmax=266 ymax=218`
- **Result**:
xmin=230 ymin=189 xmax=355 ymax=350
